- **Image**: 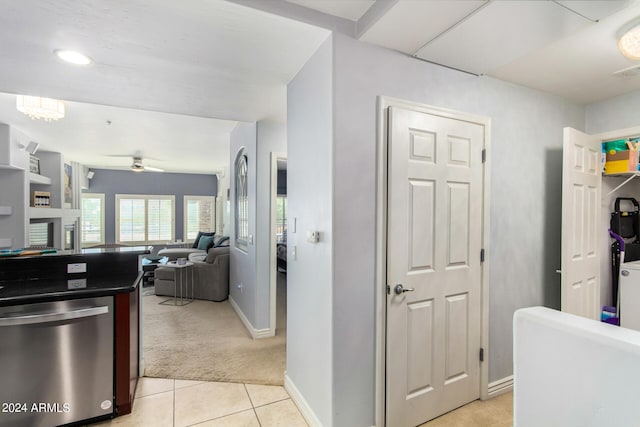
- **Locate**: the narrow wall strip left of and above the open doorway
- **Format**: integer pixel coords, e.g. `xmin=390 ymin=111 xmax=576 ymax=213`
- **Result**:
xmin=254 ymin=121 xmax=287 ymax=329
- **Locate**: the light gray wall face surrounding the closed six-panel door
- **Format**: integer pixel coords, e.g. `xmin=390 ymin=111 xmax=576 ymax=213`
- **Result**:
xmin=330 ymin=35 xmax=584 ymax=426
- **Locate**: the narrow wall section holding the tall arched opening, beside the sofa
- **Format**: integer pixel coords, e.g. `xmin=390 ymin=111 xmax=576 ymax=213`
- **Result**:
xmin=229 ymin=123 xmax=257 ymax=325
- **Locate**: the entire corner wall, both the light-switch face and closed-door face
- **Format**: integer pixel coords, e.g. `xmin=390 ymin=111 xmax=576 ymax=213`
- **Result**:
xmin=287 ymin=34 xmax=585 ymax=426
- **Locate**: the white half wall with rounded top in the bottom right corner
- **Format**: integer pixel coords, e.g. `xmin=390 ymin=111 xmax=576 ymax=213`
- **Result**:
xmin=513 ymin=307 xmax=640 ymax=427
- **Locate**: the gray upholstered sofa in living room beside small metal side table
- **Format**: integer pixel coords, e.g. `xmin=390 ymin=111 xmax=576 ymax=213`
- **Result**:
xmin=154 ymin=246 xmax=229 ymax=301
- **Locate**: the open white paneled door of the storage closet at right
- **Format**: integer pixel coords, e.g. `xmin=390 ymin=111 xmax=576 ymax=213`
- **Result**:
xmin=561 ymin=128 xmax=606 ymax=320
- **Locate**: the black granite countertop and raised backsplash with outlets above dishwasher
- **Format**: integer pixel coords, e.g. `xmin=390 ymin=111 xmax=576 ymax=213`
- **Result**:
xmin=0 ymin=248 xmax=148 ymax=306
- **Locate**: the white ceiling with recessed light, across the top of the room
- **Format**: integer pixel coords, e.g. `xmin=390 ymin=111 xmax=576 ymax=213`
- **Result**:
xmin=0 ymin=0 xmax=640 ymax=173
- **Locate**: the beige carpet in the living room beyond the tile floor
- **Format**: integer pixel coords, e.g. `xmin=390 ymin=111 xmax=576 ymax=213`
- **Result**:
xmin=142 ymin=292 xmax=286 ymax=385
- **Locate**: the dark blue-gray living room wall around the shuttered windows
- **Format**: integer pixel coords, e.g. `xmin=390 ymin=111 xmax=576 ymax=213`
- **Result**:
xmin=83 ymin=168 xmax=217 ymax=243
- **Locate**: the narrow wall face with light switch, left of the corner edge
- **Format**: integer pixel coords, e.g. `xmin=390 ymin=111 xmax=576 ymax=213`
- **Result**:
xmin=286 ymin=39 xmax=334 ymax=426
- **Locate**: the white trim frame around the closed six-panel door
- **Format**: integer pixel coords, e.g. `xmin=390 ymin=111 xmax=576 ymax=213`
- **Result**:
xmin=375 ymin=96 xmax=491 ymax=426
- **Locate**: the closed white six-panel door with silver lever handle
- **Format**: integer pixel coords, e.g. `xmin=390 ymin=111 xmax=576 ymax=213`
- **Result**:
xmin=386 ymin=107 xmax=484 ymax=427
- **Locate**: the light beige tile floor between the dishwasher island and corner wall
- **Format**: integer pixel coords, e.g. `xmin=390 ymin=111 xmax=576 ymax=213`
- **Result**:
xmin=94 ymin=377 xmax=307 ymax=427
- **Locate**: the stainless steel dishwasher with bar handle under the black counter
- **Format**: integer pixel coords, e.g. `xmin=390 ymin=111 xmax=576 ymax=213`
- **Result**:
xmin=0 ymin=296 xmax=114 ymax=427
